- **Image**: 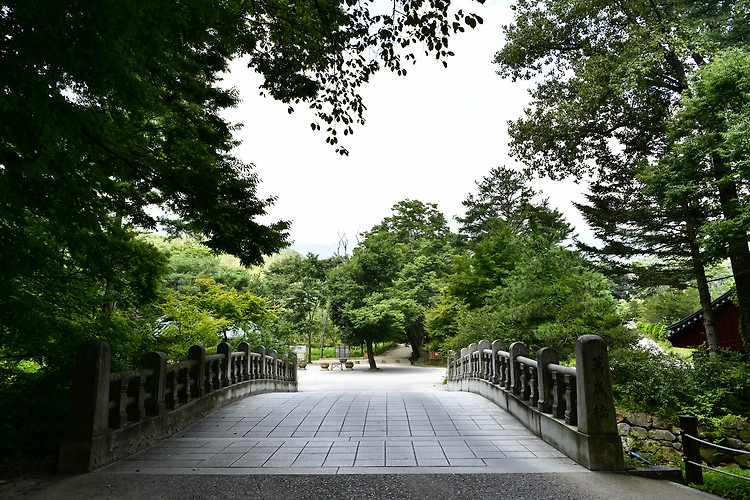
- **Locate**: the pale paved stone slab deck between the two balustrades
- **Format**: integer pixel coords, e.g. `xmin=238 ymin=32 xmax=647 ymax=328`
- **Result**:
xmin=101 ymin=365 xmax=586 ymax=474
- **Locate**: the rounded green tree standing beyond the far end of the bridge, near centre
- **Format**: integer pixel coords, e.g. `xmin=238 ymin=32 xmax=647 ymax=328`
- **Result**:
xmin=329 ymin=200 xmax=452 ymax=365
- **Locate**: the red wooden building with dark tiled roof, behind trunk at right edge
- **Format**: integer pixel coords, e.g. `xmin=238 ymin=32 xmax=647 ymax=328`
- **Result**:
xmin=666 ymin=292 xmax=745 ymax=351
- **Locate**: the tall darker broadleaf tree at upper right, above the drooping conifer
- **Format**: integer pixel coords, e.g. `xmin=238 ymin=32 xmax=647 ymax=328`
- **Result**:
xmin=496 ymin=0 xmax=750 ymax=352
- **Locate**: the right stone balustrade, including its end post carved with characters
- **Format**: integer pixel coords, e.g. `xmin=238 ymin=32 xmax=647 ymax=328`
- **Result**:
xmin=448 ymin=335 xmax=624 ymax=470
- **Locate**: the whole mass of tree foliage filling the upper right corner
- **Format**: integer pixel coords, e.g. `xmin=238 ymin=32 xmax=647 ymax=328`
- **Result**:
xmin=496 ymin=0 xmax=750 ymax=351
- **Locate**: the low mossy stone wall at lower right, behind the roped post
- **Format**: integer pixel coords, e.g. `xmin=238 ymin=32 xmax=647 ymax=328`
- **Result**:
xmin=617 ymin=413 xmax=750 ymax=469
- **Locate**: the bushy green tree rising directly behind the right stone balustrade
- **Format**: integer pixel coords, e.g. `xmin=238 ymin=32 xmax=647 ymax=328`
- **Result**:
xmin=430 ymin=242 xmax=634 ymax=359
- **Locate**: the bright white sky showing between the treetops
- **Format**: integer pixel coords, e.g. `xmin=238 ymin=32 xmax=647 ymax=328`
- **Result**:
xmin=220 ymin=0 xmax=589 ymax=254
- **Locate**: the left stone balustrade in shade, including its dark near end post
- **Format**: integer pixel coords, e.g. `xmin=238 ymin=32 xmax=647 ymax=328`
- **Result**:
xmin=58 ymin=340 xmax=297 ymax=472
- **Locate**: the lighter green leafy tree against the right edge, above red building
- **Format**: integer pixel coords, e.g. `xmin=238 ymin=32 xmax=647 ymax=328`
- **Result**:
xmin=660 ymin=49 xmax=750 ymax=352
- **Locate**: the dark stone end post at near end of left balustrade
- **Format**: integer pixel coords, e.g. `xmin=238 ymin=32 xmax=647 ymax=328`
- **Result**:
xmin=58 ymin=340 xmax=111 ymax=472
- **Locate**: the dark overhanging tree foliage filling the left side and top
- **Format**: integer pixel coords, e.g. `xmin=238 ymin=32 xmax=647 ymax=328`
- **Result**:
xmin=0 ymin=0 xmax=482 ymax=468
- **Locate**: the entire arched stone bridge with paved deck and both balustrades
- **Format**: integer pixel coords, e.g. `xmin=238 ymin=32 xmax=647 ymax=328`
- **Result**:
xmin=59 ymin=337 xmax=623 ymax=474
